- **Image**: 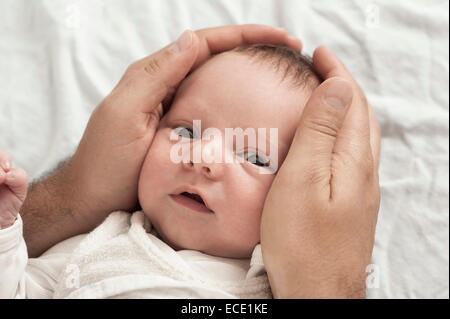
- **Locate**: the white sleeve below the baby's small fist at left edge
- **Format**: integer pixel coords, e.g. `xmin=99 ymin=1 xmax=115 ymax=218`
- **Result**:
xmin=0 ymin=214 xmax=28 ymax=298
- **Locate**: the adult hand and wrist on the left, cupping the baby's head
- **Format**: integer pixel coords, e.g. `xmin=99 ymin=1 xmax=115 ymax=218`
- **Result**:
xmin=21 ymin=25 xmax=301 ymax=256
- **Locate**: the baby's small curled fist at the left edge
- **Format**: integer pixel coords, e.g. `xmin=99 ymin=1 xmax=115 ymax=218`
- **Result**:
xmin=0 ymin=150 xmax=28 ymax=229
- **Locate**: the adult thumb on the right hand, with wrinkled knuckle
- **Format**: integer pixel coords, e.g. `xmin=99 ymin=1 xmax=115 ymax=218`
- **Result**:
xmin=288 ymin=77 xmax=353 ymax=198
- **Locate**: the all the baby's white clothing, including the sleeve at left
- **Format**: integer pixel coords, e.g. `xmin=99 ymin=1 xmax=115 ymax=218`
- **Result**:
xmin=0 ymin=211 xmax=272 ymax=298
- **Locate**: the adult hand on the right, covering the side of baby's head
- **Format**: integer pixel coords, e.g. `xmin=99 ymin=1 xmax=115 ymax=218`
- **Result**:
xmin=261 ymin=47 xmax=380 ymax=298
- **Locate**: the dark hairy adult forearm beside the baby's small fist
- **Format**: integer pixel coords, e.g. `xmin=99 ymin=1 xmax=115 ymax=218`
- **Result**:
xmin=21 ymin=159 xmax=105 ymax=257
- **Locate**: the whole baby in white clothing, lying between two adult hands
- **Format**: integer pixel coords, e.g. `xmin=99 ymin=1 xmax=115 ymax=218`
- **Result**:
xmin=0 ymin=45 xmax=320 ymax=298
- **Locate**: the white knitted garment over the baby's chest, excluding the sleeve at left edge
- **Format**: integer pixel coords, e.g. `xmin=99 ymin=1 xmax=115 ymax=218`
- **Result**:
xmin=53 ymin=211 xmax=272 ymax=298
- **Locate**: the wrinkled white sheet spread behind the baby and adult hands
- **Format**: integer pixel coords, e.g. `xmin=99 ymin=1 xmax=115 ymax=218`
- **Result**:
xmin=0 ymin=0 xmax=449 ymax=298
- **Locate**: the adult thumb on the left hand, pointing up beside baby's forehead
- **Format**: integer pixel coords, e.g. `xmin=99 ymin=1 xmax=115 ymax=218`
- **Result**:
xmin=120 ymin=30 xmax=199 ymax=113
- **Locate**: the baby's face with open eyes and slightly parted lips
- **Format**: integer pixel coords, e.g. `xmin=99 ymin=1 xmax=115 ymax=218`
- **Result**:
xmin=139 ymin=52 xmax=309 ymax=258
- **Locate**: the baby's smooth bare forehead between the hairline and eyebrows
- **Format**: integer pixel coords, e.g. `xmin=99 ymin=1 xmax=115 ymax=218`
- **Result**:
xmin=172 ymin=52 xmax=311 ymax=127
